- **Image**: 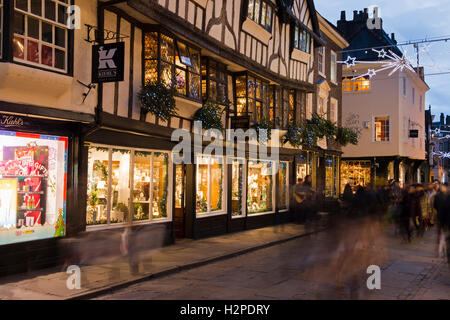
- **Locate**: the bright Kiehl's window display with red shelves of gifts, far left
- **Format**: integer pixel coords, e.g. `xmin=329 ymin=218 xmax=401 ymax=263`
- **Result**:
xmin=0 ymin=131 xmax=68 ymax=245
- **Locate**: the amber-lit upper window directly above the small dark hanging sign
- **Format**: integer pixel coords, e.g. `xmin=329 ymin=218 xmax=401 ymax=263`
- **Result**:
xmin=234 ymin=73 xmax=269 ymax=122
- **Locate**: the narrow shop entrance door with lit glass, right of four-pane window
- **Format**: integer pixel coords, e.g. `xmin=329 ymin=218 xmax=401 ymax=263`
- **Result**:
xmin=174 ymin=164 xmax=186 ymax=239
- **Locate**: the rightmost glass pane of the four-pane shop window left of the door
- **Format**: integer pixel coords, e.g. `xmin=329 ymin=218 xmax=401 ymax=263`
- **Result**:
xmin=152 ymin=152 xmax=169 ymax=219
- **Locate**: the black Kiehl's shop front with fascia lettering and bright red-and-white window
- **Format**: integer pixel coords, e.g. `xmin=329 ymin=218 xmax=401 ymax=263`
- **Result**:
xmin=0 ymin=108 xmax=79 ymax=275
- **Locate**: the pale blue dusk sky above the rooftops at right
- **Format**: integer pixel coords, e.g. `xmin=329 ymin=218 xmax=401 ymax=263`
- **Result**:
xmin=314 ymin=0 xmax=450 ymax=118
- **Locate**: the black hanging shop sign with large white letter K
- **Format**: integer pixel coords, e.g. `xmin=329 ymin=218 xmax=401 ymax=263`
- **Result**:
xmin=92 ymin=42 xmax=125 ymax=83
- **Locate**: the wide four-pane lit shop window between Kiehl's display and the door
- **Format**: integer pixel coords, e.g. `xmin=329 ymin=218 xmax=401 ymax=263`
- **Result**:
xmin=86 ymin=146 xmax=169 ymax=225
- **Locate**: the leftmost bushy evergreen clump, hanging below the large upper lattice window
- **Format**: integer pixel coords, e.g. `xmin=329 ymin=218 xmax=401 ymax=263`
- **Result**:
xmin=137 ymin=79 xmax=177 ymax=121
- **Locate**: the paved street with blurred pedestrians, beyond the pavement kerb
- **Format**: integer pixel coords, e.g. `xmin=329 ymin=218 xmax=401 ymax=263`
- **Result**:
xmin=97 ymin=221 xmax=450 ymax=299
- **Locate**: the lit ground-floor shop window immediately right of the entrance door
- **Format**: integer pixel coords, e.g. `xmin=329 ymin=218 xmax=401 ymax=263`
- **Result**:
xmin=196 ymin=156 xmax=225 ymax=214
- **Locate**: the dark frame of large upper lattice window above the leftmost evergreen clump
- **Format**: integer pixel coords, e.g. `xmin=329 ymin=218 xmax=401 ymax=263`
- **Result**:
xmin=142 ymin=27 xmax=202 ymax=102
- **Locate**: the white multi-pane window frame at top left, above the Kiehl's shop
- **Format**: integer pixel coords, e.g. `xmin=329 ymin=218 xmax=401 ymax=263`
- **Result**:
xmin=9 ymin=0 xmax=73 ymax=75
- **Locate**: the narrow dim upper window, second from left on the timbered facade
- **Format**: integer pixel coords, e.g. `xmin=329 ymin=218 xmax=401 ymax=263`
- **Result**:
xmin=202 ymin=57 xmax=228 ymax=105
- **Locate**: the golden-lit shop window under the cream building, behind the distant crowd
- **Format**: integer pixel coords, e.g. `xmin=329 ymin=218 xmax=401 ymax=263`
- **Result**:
xmin=341 ymin=161 xmax=371 ymax=194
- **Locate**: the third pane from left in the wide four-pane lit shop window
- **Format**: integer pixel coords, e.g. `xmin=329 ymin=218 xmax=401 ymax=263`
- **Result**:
xmin=133 ymin=151 xmax=152 ymax=220
